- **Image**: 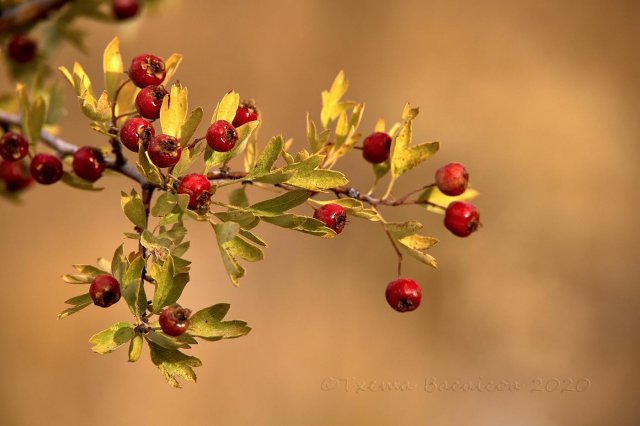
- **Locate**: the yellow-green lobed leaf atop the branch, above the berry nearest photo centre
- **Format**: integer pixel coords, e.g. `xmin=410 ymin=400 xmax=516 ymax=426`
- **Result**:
xmin=283 ymin=154 xmax=349 ymax=191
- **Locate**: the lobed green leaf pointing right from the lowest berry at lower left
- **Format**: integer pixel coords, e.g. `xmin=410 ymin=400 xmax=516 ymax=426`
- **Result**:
xmin=188 ymin=303 xmax=251 ymax=341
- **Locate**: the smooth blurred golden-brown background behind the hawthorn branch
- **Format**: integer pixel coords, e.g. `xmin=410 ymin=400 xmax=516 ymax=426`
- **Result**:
xmin=0 ymin=0 xmax=640 ymax=426
